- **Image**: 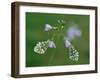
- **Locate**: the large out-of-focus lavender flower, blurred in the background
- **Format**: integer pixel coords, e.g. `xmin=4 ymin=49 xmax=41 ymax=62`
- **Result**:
xmin=67 ymin=26 xmax=82 ymax=41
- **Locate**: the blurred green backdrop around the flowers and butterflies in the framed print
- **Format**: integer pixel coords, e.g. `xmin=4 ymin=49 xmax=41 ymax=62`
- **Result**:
xmin=26 ymin=12 xmax=89 ymax=67
